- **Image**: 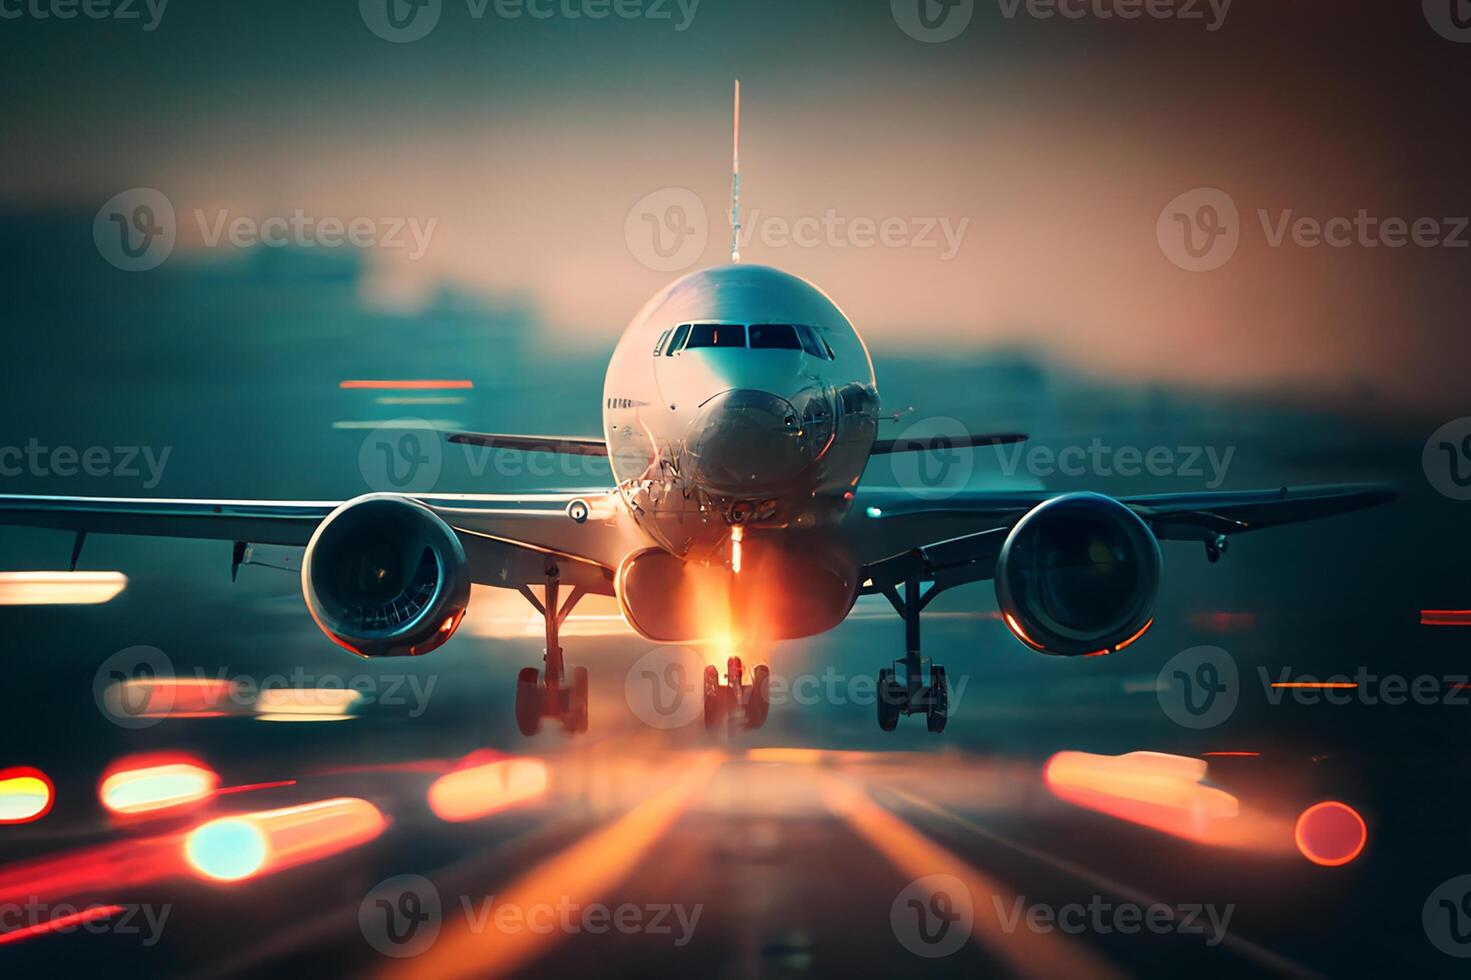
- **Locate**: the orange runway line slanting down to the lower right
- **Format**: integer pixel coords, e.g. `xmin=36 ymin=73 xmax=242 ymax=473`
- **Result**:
xmin=819 ymin=773 xmax=1119 ymax=980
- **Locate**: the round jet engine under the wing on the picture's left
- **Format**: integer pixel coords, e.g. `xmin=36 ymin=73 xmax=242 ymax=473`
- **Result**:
xmin=302 ymin=494 xmax=471 ymax=656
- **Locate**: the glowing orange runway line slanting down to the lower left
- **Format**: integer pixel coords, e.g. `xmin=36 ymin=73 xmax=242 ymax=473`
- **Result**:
xmin=380 ymin=752 xmax=721 ymax=979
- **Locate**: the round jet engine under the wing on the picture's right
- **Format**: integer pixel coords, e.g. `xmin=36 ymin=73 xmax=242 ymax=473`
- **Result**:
xmin=996 ymin=493 xmax=1161 ymax=656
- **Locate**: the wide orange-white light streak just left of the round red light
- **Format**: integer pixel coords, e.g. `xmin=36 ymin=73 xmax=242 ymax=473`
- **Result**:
xmin=1043 ymin=752 xmax=1292 ymax=853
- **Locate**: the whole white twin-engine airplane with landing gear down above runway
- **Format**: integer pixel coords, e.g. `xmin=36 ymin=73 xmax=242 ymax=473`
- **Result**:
xmin=0 ymin=81 xmax=1395 ymax=736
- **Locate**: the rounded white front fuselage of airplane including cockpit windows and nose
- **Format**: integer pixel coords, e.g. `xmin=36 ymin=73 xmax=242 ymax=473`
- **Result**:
xmin=603 ymin=265 xmax=878 ymax=561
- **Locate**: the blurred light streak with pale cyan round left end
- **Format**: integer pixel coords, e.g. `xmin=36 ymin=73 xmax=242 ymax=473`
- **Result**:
xmin=184 ymin=796 xmax=388 ymax=881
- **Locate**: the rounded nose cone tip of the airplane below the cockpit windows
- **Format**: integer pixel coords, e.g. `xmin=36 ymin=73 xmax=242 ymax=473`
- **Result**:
xmin=688 ymin=388 xmax=813 ymax=496
